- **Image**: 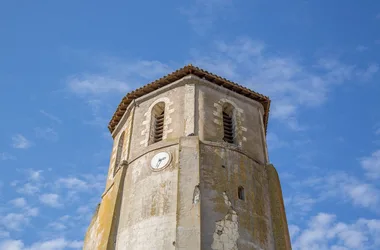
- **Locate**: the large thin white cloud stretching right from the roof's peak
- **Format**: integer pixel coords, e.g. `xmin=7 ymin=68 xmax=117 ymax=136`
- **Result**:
xmin=192 ymin=37 xmax=378 ymax=130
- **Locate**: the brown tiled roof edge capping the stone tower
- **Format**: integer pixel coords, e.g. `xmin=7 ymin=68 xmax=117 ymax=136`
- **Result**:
xmin=108 ymin=64 xmax=270 ymax=133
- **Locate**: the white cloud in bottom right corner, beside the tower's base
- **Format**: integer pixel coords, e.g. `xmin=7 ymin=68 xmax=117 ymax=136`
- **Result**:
xmin=291 ymin=213 xmax=380 ymax=250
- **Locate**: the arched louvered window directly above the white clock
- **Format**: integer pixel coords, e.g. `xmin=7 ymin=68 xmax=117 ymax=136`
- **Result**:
xmin=150 ymin=102 xmax=165 ymax=144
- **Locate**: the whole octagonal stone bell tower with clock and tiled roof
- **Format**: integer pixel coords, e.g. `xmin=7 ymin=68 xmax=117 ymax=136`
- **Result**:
xmin=84 ymin=65 xmax=291 ymax=250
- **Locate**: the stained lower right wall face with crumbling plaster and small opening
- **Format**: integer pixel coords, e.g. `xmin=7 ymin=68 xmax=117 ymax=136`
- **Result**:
xmin=200 ymin=143 xmax=273 ymax=250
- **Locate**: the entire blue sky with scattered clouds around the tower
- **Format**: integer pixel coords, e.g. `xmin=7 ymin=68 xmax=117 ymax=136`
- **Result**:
xmin=0 ymin=0 xmax=380 ymax=250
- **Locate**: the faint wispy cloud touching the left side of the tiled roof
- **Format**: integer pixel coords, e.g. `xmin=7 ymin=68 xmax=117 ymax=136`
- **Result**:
xmin=67 ymin=57 xmax=172 ymax=128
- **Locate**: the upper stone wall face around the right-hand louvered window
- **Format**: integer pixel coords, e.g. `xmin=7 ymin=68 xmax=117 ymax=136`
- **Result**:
xmin=197 ymin=83 xmax=266 ymax=163
